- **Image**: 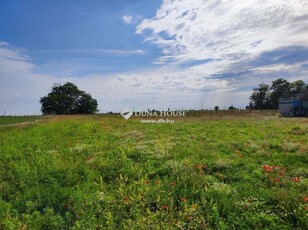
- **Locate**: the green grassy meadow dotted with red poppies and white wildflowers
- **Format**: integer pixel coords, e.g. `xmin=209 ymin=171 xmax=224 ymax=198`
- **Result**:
xmin=0 ymin=115 xmax=308 ymax=230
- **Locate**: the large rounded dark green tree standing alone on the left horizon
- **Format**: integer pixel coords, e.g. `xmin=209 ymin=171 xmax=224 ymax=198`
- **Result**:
xmin=40 ymin=82 xmax=98 ymax=114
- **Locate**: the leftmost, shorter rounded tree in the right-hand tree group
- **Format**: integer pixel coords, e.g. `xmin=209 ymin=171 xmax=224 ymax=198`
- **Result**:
xmin=250 ymin=83 xmax=271 ymax=109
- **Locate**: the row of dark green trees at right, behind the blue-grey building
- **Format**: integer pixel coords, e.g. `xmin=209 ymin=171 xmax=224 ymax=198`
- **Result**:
xmin=248 ymin=78 xmax=308 ymax=109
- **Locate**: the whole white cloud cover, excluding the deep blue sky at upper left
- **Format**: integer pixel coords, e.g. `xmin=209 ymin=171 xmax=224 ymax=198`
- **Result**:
xmin=0 ymin=0 xmax=308 ymax=114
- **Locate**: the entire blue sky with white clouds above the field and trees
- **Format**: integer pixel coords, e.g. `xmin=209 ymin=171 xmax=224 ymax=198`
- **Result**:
xmin=0 ymin=0 xmax=308 ymax=115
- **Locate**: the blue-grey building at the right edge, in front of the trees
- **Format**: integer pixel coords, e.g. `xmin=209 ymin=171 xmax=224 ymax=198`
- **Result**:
xmin=279 ymin=90 xmax=308 ymax=117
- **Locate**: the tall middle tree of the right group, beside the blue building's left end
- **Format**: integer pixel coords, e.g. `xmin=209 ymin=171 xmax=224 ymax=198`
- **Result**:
xmin=270 ymin=78 xmax=291 ymax=109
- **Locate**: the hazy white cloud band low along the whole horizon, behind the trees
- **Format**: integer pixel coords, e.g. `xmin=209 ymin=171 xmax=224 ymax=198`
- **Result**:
xmin=0 ymin=37 xmax=308 ymax=114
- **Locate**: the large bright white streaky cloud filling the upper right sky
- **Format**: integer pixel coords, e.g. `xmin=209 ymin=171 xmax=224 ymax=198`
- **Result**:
xmin=136 ymin=0 xmax=308 ymax=65
